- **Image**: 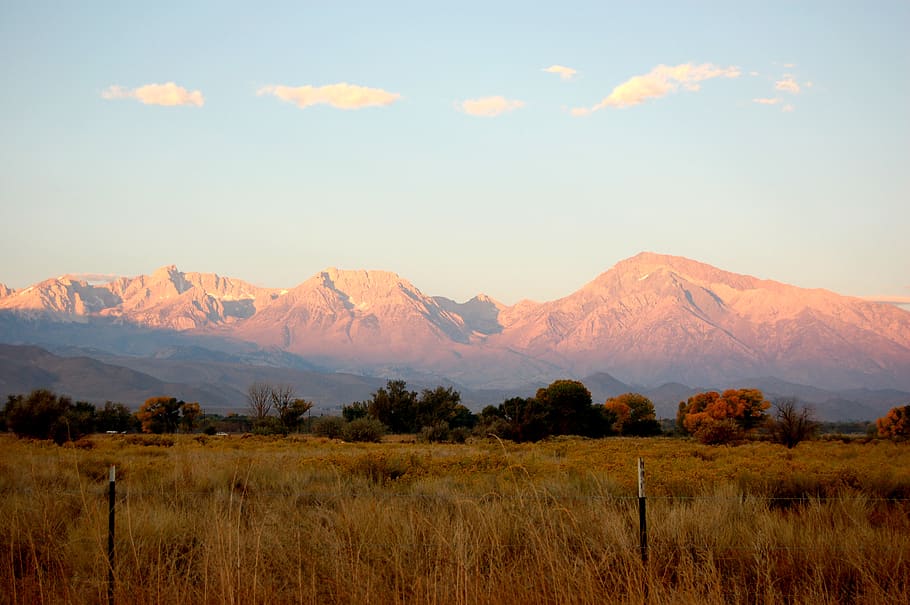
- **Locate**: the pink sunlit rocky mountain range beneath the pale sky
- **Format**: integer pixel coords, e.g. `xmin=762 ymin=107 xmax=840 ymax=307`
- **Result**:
xmin=0 ymin=252 xmax=910 ymax=418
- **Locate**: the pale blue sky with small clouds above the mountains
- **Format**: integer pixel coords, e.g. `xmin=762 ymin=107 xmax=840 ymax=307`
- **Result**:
xmin=0 ymin=0 xmax=910 ymax=304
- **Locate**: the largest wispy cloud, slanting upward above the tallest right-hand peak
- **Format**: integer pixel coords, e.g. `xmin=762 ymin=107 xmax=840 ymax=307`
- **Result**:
xmin=572 ymin=63 xmax=742 ymax=115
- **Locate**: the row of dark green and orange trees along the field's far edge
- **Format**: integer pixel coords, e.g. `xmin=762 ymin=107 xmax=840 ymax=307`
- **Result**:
xmin=0 ymin=380 xmax=910 ymax=447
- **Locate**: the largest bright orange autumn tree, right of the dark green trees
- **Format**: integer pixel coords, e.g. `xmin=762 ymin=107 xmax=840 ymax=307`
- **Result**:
xmin=676 ymin=389 xmax=771 ymax=443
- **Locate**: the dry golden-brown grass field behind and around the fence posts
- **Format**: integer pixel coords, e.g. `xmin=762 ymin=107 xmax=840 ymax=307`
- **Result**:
xmin=0 ymin=435 xmax=910 ymax=605
